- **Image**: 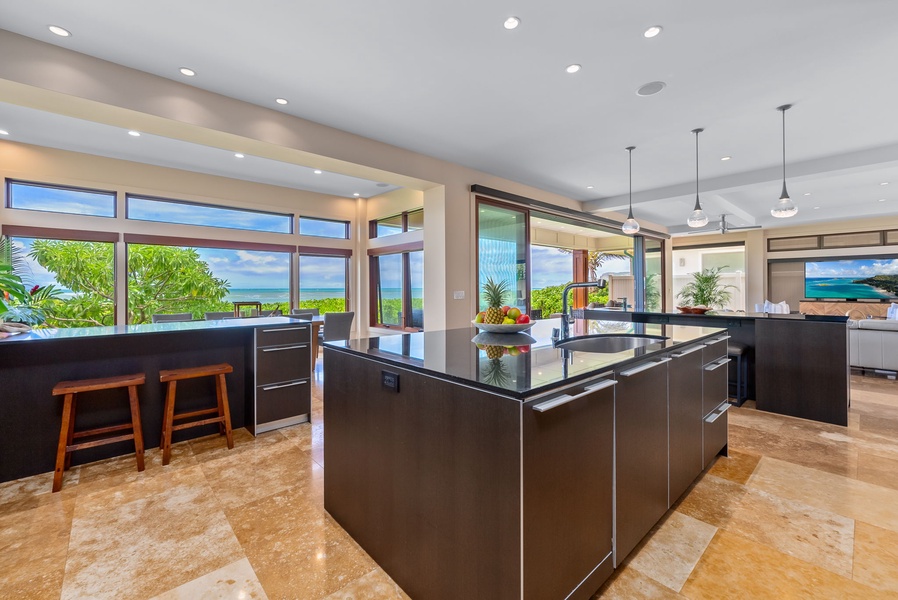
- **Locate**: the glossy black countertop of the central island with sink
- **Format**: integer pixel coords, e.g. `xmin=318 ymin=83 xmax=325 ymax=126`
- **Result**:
xmin=324 ymin=319 xmax=726 ymax=399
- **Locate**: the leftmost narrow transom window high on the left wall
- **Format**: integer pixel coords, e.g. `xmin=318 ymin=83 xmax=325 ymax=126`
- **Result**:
xmin=6 ymin=180 xmax=115 ymax=217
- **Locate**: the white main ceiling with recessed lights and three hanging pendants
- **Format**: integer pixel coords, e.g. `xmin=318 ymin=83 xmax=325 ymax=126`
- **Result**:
xmin=0 ymin=0 xmax=898 ymax=232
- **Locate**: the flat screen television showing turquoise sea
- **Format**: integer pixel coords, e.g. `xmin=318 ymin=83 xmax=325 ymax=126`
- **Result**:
xmin=804 ymin=257 xmax=898 ymax=300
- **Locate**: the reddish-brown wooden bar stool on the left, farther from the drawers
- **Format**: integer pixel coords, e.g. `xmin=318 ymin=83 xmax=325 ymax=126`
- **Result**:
xmin=53 ymin=373 xmax=146 ymax=492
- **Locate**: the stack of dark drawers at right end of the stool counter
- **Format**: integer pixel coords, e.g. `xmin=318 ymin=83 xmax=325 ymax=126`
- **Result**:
xmin=246 ymin=324 xmax=312 ymax=435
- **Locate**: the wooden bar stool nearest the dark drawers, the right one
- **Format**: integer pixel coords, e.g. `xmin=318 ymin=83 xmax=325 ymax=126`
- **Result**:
xmin=159 ymin=363 xmax=234 ymax=465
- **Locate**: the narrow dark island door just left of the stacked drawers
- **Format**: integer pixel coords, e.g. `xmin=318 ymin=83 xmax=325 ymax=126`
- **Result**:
xmin=668 ymin=346 xmax=705 ymax=504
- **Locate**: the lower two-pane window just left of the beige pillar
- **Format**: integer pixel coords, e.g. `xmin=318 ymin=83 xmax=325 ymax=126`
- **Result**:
xmin=369 ymin=244 xmax=424 ymax=329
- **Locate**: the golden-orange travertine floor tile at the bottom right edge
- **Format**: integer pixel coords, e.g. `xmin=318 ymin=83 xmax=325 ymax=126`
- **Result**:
xmin=682 ymin=531 xmax=888 ymax=600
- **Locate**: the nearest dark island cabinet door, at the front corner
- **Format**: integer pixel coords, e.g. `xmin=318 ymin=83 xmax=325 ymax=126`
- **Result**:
xmin=522 ymin=379 xmax=615 ymax=599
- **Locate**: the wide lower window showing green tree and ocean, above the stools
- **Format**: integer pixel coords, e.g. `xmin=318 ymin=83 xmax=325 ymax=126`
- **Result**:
xmin=125 ymin=236 xmax=290 ymax=324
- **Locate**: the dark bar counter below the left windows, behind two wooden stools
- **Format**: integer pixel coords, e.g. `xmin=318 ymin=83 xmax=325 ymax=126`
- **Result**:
xmin=0 ymin=317 xmax=311 ymax=482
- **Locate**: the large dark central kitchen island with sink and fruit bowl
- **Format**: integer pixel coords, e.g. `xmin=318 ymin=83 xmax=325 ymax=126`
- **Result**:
xmin=324 ymin=320 xmax=729 ymax=600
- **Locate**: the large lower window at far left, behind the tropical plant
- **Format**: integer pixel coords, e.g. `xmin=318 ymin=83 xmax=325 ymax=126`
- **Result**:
xmin=6 ymin=233 xmax=115 ymax=328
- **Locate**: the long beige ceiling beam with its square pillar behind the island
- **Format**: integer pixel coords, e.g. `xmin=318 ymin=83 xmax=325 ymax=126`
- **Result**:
xmin=0 ymin=31 xmax=600 ymax=329
